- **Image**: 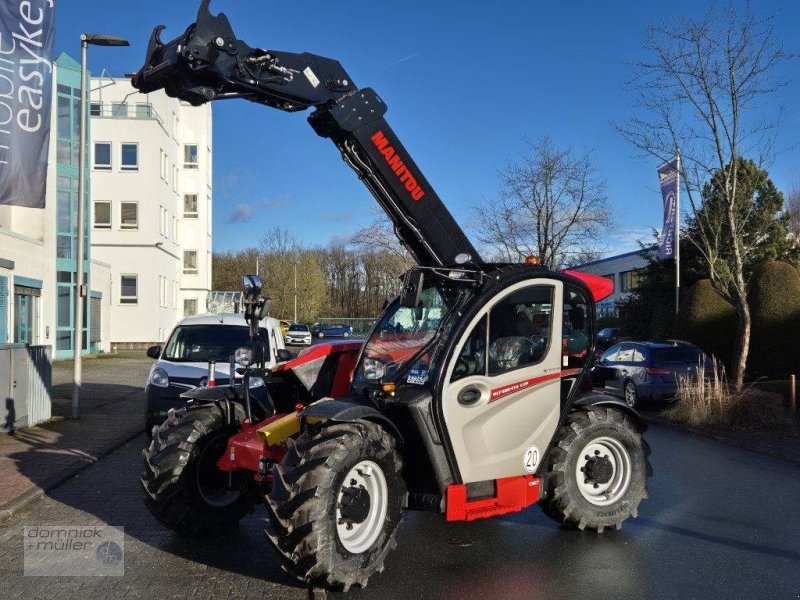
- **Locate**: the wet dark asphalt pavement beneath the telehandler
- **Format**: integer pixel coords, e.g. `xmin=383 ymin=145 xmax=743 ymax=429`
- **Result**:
xmin=0 ymin=426 xmax=800 ymax=600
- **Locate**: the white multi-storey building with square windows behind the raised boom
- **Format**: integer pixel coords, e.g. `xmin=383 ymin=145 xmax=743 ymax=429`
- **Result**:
xmin=89 ymin=78 xmax=212 ymax=348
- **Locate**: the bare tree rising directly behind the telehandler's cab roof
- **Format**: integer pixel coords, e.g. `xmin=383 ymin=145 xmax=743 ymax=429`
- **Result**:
xmin=475 ymin=137 xmax=611 ymax=268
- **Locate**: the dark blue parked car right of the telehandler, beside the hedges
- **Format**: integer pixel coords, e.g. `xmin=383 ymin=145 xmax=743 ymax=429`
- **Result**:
xmin=594 ymin=342 xmax=709 ymax=406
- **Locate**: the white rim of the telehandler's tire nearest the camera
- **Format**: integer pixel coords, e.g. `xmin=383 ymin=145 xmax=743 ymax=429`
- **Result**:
xmin=336 ymin=460 xmax=389 ymax=554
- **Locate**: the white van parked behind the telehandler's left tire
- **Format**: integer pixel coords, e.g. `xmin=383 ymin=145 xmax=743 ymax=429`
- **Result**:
xmin=145 ymin=313 xmax=291 ymax=433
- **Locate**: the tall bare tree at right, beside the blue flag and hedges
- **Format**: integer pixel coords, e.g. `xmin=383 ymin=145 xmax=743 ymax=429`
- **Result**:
xmin=618 ymin=6 xmax=788 ymax=391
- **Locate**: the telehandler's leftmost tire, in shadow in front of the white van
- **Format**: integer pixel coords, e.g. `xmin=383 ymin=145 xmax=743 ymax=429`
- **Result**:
xmin=141 ymin=404 xmax=254 ymax=538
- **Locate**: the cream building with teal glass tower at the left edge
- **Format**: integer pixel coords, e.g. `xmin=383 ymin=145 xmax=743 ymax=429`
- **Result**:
xmin=0 ymin=54 xmax=111 ymax=358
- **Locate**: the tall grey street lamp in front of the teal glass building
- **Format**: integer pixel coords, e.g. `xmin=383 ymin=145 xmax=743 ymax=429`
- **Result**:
xmin=72 ymin=33 xmax=130 ymax=419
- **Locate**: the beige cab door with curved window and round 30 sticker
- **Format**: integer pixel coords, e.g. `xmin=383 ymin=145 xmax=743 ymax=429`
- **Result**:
xmin=442 ymin=279 xmax=567 ymax=483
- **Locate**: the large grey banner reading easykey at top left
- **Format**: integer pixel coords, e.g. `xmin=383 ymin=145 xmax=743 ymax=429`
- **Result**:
xmin=0 ymin=0 xmax=56 ymax=208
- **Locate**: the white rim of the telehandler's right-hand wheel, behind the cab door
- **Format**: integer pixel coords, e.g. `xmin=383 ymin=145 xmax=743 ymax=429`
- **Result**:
xmin=575 ymin=436 xmax=631 ymax=506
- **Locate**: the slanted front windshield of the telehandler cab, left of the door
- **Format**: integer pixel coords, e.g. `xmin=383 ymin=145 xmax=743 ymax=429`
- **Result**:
xmin=353 ymin=282 xmax=455 ymax=386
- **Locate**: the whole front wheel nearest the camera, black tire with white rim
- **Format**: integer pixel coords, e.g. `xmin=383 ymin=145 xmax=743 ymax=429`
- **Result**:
xmin=266 ymin=421 xmax=403 ymax=591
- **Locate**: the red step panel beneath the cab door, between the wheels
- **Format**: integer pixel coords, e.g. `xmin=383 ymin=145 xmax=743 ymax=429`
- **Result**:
xmin=446 ymin=475 xmax=540 ymax=521
